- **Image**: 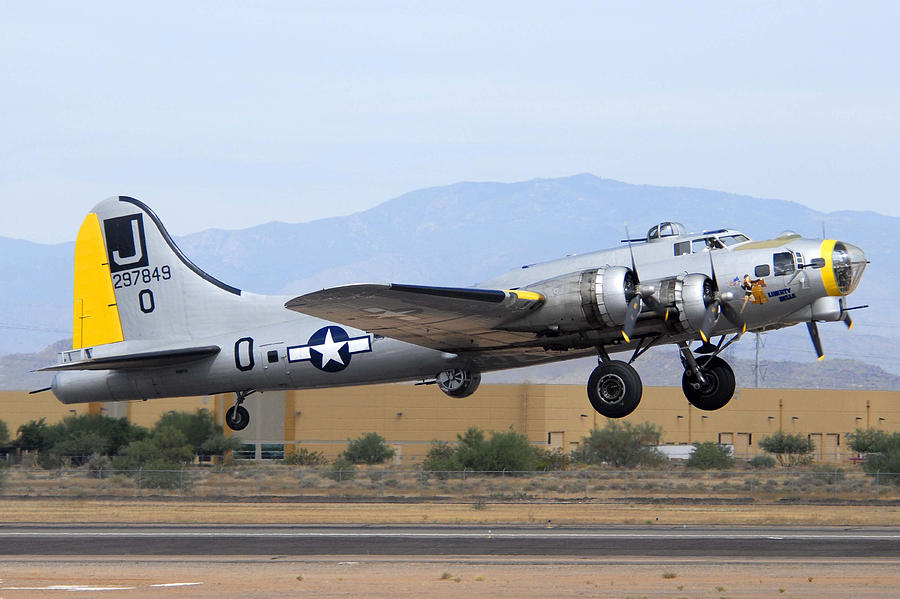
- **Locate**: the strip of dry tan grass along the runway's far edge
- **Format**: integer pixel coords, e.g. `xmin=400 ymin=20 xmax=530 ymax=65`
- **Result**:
xmin=0 ymin=499 xmax=900 ymax=526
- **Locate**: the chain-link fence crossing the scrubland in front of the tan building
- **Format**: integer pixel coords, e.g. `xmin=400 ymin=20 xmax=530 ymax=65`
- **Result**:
xmin=0 ymin=465 xmax=900 ymax=502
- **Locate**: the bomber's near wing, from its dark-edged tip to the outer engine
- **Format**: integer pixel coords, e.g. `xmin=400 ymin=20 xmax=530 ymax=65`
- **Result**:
xmin=285 ymin=283 xmax=544 ymax=353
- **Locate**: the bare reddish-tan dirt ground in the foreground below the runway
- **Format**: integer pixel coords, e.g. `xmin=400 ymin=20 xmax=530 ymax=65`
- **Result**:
xmin=0 ymin=556 xmax=900 ymax=599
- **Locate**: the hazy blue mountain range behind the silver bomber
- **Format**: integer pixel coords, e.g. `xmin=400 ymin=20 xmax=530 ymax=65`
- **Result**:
xmin=0 ymin=174 xmax=900 ymax=388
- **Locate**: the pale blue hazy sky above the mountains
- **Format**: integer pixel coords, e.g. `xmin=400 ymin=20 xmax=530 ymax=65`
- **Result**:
xmin=0 ymin=1 xmax=900 ymax=242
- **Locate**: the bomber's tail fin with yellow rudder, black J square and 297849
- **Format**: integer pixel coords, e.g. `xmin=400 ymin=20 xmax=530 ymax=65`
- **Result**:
xmin=72 ymin=196 xmax=244 ymax=349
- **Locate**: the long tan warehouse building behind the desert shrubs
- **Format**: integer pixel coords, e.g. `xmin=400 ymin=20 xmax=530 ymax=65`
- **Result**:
xmin=0 ymin=384 xmax=900 ymax=466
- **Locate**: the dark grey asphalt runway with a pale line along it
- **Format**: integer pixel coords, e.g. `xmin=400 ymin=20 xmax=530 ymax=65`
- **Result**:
xmin=0 ymin=525 xmax=900 ymax=560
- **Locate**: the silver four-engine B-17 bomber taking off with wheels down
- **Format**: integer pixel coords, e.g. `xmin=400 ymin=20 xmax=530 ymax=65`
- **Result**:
xmin=43 ymin=196 xmax=867 ymax=430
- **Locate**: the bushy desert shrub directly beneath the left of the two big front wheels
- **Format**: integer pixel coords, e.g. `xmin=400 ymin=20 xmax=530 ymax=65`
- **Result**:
xmin=572 ymin=419 xmax=666 ymax=468
